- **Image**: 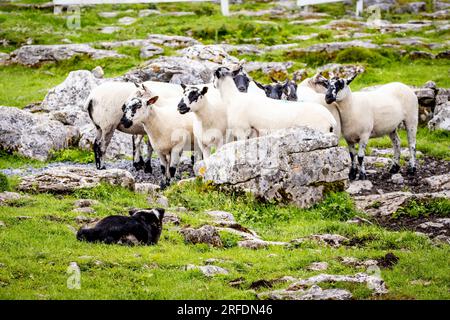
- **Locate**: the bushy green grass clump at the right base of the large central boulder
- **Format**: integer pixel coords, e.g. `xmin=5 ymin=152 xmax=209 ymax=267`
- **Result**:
xmin=316 ymin=192 xmax=357 ymax=221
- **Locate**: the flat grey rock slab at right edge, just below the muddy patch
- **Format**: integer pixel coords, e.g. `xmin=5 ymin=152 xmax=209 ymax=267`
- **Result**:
xmin=353 ymin=191 xmax=450 ymax=216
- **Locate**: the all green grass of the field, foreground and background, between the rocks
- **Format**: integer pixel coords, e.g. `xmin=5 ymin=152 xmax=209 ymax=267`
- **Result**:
xmin=0 ymin=0 xmax=450 ymax=299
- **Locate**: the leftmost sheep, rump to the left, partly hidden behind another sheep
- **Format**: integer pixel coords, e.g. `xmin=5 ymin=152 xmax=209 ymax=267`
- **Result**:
xmin=85 ymin=81 xmax=183 ymax=173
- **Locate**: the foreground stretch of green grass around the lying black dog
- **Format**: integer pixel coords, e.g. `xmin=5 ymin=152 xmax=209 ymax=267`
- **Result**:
xmin=0 ymin=181 xmax=450 ymax=299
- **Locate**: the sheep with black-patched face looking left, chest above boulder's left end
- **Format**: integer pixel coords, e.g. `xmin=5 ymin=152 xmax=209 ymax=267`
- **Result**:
xmin=178 ymin=84 xmax=227 ymax=158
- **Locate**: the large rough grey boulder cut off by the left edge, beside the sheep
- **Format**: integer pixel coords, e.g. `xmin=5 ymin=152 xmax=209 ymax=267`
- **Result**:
xmin=0 ymin=106 xmax=71 ymax=161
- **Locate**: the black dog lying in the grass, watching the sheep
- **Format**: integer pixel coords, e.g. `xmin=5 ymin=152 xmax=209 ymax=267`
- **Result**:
xmin=77 ymin=208 xmax=164 ymax=245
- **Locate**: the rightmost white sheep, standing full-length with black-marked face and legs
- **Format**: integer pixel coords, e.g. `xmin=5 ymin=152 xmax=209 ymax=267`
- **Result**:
xmin=322 ymin=75 xmax=419 ymax=180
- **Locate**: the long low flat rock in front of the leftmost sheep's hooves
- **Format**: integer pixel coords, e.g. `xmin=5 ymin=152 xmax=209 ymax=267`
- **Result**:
xmin=18 ymin=166 xmax=134 ymax=193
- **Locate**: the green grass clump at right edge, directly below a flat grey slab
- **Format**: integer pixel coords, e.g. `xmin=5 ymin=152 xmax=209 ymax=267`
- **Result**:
xmin=392 ymin=198 xmax=450 ymax=219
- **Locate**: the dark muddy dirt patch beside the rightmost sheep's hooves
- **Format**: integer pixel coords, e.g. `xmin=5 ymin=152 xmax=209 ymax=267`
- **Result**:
xmin=359 ymin=156 xmax=450 ymax=195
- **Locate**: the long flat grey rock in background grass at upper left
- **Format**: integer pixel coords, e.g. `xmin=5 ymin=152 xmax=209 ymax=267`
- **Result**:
xmin=11 ymin=44 xmax=126 ymax=67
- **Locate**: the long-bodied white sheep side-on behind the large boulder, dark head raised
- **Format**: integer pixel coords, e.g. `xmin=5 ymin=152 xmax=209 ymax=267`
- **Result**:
xmin=214 ymin=67 xmax=336 ymax=139
